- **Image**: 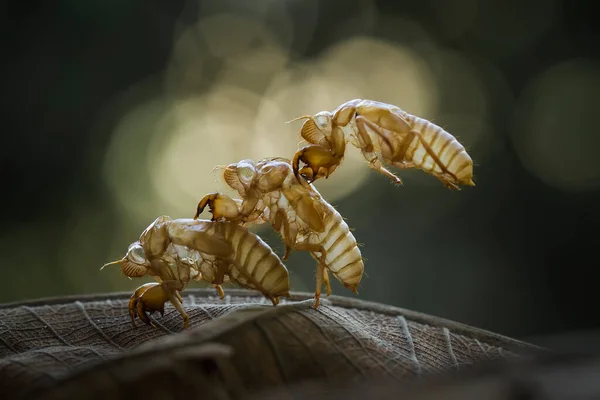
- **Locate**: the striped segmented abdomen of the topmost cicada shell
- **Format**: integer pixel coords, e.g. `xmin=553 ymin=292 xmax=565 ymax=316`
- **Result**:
xmin=404 ymin=114 xmax=473 ymax=184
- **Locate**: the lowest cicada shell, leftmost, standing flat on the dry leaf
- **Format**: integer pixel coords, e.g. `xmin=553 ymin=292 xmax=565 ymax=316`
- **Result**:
xmin=102 ymin=216 xmax=290 ymax=328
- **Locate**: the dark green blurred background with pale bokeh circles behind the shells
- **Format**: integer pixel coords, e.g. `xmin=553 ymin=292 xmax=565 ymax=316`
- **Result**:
xmin=0 ymin=0 xmax=600 ymax=339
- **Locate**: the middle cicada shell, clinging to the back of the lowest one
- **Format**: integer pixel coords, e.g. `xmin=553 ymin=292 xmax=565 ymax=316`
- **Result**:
xmin=194 ymin=158 xmax=364 ymax=308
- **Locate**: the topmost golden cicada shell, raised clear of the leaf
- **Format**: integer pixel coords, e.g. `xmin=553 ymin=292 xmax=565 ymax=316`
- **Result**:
xmin=290 ymin=99 xmax=475 ymax=190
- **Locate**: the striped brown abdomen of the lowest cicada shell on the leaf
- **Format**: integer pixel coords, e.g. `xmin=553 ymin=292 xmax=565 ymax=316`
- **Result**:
xmin=221 ymin=222 xmax=290 ymax=297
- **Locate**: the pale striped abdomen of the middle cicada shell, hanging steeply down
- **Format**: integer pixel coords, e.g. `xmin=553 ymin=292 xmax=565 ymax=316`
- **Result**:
xmin=311 ymin=203 xmax=364 ymax=291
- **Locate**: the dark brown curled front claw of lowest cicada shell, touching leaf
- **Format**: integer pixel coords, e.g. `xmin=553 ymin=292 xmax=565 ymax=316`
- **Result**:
xmin=129 ymin=282 xmax=169 ymax=328
